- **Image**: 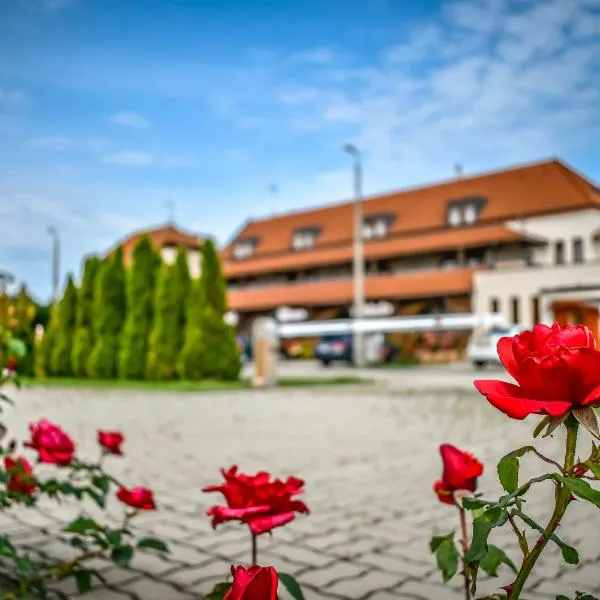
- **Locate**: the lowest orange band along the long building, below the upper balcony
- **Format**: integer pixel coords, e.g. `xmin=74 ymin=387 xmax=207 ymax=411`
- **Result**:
xmin=228 ymin=268 xmax=474 ymax=311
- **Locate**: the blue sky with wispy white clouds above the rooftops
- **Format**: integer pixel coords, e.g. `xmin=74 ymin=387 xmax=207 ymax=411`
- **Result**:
xmin=0 ymin=0 xmax=600 ymax=299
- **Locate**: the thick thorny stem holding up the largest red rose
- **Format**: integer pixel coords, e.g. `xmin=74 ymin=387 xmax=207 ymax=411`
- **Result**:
xmin=508 ymin=416 xmax=578 ymax=600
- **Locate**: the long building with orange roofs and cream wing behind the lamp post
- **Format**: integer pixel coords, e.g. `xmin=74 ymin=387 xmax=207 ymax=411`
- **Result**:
xmin=222 ymin=160 xmax=600 ymax=338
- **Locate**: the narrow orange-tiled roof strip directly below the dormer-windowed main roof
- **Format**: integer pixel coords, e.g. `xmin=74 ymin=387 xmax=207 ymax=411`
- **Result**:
xmin=223 ymin=225 xmax=526 ymax=278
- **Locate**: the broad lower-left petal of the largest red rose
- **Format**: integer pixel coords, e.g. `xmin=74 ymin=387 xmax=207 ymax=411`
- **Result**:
xmin=474 ymin=379 xmax=572 ymax=420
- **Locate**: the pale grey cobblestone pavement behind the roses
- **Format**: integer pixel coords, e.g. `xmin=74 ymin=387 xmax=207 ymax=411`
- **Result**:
xmin=1 ymin=384 xmax=600 ymax=600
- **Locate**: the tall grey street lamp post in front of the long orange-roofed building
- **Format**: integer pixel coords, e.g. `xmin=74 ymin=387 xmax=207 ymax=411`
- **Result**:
xmin=343 ymin=144 xmax=365 ymax=367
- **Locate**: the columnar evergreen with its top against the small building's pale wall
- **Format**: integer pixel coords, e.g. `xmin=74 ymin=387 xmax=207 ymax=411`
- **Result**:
xmin=146 ymin=264 xmax=180 ymax=380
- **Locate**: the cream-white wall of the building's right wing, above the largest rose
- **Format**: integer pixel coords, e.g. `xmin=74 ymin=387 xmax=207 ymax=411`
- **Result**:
xmin=471 ymin=258 xmax=600 ymax=327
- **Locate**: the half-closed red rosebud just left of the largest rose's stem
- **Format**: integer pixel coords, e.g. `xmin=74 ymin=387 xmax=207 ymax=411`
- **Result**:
xmin=433 ymin=444 xmax=483 ymax=504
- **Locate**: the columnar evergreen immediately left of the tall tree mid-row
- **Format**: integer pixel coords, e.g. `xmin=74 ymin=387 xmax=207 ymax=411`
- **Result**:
xmin=88 ymin=247 xmax=126 ymax=379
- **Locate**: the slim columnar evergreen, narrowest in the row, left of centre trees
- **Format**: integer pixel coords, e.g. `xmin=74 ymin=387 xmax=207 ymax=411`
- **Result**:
xmin=71 ymin=256 xmax=102 ymax=377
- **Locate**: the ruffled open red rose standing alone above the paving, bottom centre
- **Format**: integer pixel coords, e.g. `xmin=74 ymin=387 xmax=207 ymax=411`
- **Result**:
xmin=202 ymin=466 xmax=308 ymax=535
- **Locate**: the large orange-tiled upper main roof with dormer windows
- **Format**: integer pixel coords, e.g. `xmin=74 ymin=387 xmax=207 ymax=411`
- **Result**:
xmin=222 ymin=160 xmax=600 ymax=272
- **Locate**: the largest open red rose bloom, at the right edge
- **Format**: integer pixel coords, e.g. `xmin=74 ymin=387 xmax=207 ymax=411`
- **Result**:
xmin=475 ymin=323 xmax=600 ymax=419
